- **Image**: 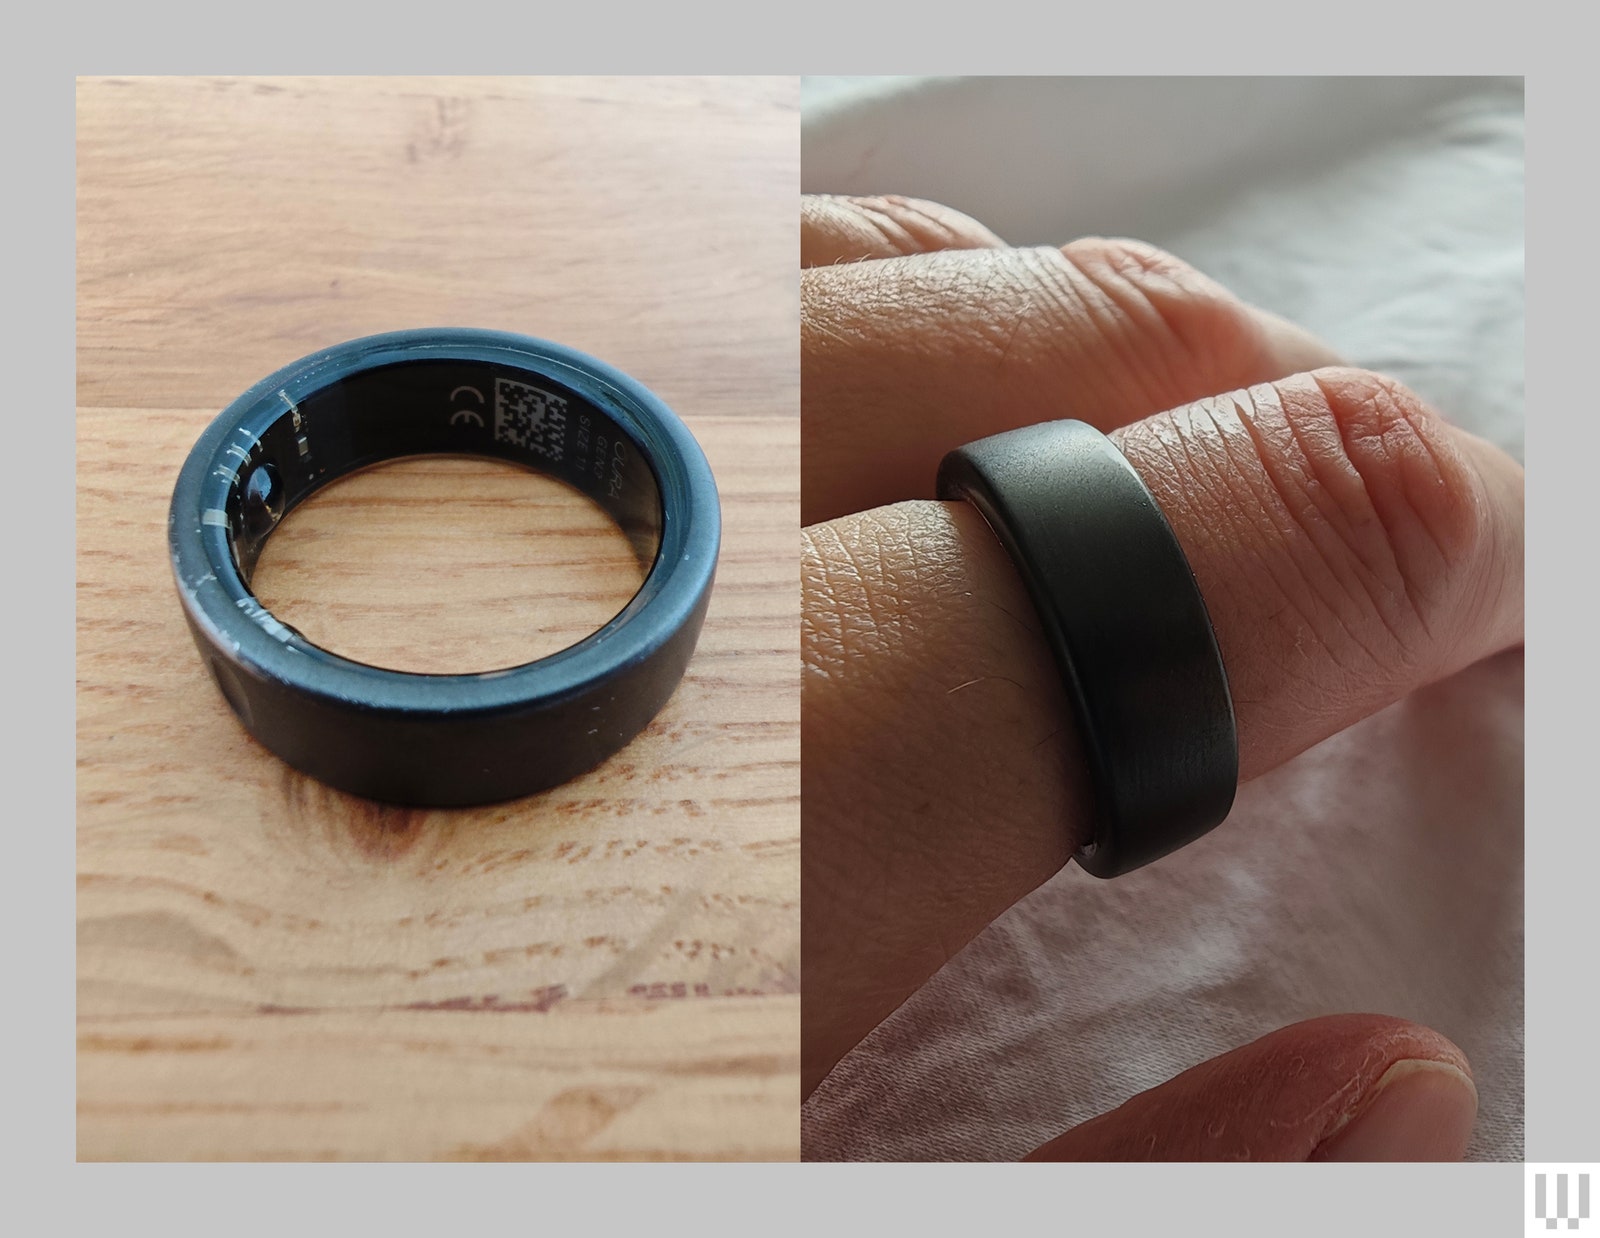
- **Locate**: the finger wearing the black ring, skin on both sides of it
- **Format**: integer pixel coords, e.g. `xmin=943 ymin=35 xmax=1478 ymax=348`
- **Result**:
xmin=802 ymin=369 xmax=1522 ymax=1086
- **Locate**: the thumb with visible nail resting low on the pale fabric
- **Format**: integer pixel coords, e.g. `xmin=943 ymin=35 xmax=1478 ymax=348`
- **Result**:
xmin=1027 ymin=1014 xmax=1478 ymax=1161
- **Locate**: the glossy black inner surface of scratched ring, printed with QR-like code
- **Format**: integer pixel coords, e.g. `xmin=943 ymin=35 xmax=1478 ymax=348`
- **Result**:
xmin=224 ymin=360 xmax=662 ymax=585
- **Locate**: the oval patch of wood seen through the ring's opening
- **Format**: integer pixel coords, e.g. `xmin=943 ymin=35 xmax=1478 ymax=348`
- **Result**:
xmin=251 ymin=456 xmax=640 ymax=675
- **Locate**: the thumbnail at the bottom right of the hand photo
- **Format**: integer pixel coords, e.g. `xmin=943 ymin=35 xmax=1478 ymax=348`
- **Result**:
xmin=1312 ymin=1059 xmax=1478 ymax=1161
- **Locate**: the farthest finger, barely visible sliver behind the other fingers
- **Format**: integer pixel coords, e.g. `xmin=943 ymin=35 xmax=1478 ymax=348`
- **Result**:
xmin=800 ymin=195 xmax=1005 ymax=267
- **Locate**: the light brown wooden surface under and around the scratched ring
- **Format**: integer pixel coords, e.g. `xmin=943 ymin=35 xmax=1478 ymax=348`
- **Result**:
xmin=77 ymin=78 xmax=800 ymax=1160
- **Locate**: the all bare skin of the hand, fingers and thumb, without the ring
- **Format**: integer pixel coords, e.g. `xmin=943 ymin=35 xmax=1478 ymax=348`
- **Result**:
xmin=802 ymin=198 xmax=1523 ymax=1160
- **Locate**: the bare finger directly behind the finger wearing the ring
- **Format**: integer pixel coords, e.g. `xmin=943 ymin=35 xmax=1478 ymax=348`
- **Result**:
xmin=800 ymin=237 xmax=1338 ymax=525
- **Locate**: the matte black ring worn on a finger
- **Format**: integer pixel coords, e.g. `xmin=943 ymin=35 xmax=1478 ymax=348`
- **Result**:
xmin=939 ymin=421 xmax=1238 ymax=877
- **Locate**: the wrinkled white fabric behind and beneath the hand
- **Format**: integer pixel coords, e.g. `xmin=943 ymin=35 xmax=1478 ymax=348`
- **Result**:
xmin=802 ymin=78 xmax=1523 ymax=1161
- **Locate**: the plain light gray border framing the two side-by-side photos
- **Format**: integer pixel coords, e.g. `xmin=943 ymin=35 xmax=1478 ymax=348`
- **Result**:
xmin=28 ymin=24 xmax=1600 ymax=1238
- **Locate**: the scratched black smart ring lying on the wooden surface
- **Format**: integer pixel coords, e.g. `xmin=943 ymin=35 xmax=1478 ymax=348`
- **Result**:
xmin=168 ymin=328 xmax=722 ymax=806
